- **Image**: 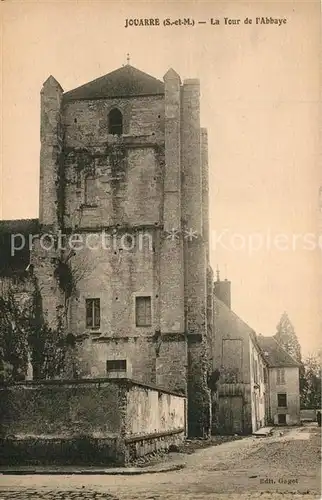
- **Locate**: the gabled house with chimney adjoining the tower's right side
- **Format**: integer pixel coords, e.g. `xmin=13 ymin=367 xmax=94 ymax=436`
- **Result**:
xmin=212 ymin=273 xmax=267 ymax=434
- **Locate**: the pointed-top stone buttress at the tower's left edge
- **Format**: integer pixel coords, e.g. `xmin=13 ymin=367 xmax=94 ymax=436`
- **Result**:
xmin=37 ymin=76 xmax=65 ymax=328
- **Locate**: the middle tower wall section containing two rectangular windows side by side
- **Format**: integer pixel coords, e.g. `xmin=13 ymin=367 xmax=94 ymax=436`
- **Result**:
xmin=67 ymin=231 xmax=155 ymax=338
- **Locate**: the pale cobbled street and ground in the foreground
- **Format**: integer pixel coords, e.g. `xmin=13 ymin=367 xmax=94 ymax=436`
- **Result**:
xmin=0 ymin=424 xmax=321 ymax=500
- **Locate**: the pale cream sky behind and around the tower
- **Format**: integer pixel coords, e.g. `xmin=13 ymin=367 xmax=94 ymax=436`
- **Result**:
xmin=0 ymin=0 xmax=322 ymax=355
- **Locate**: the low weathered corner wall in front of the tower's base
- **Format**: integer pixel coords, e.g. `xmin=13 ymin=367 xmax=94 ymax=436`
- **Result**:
xmin=0 ymin=379 xmax=186 ymax=465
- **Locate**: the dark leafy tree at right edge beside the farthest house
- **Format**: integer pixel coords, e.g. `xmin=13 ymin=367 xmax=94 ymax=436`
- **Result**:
xmin=301 ymin=354 xmax=321 ymax=409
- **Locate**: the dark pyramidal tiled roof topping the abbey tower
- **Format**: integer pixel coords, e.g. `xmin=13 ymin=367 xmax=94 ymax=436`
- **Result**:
xmin=64 ymin=64 xmax=164 ymax=101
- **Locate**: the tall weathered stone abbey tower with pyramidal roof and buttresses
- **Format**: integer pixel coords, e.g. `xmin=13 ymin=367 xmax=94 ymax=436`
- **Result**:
xmin=4 ymin=64 xmax=213 ymax=435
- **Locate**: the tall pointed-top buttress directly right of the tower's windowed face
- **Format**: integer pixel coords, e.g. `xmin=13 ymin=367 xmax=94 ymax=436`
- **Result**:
xmin=160 ymin=70 xmax=185 ymax=334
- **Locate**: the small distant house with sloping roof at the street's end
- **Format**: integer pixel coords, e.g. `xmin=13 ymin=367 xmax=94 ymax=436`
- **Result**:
xmin=257 ymin=335 xmax=301 ymax=425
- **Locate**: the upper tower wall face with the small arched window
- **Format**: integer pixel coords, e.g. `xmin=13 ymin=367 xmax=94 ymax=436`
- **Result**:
xmin=64 ymin=96 xmax=164 ymax=228
